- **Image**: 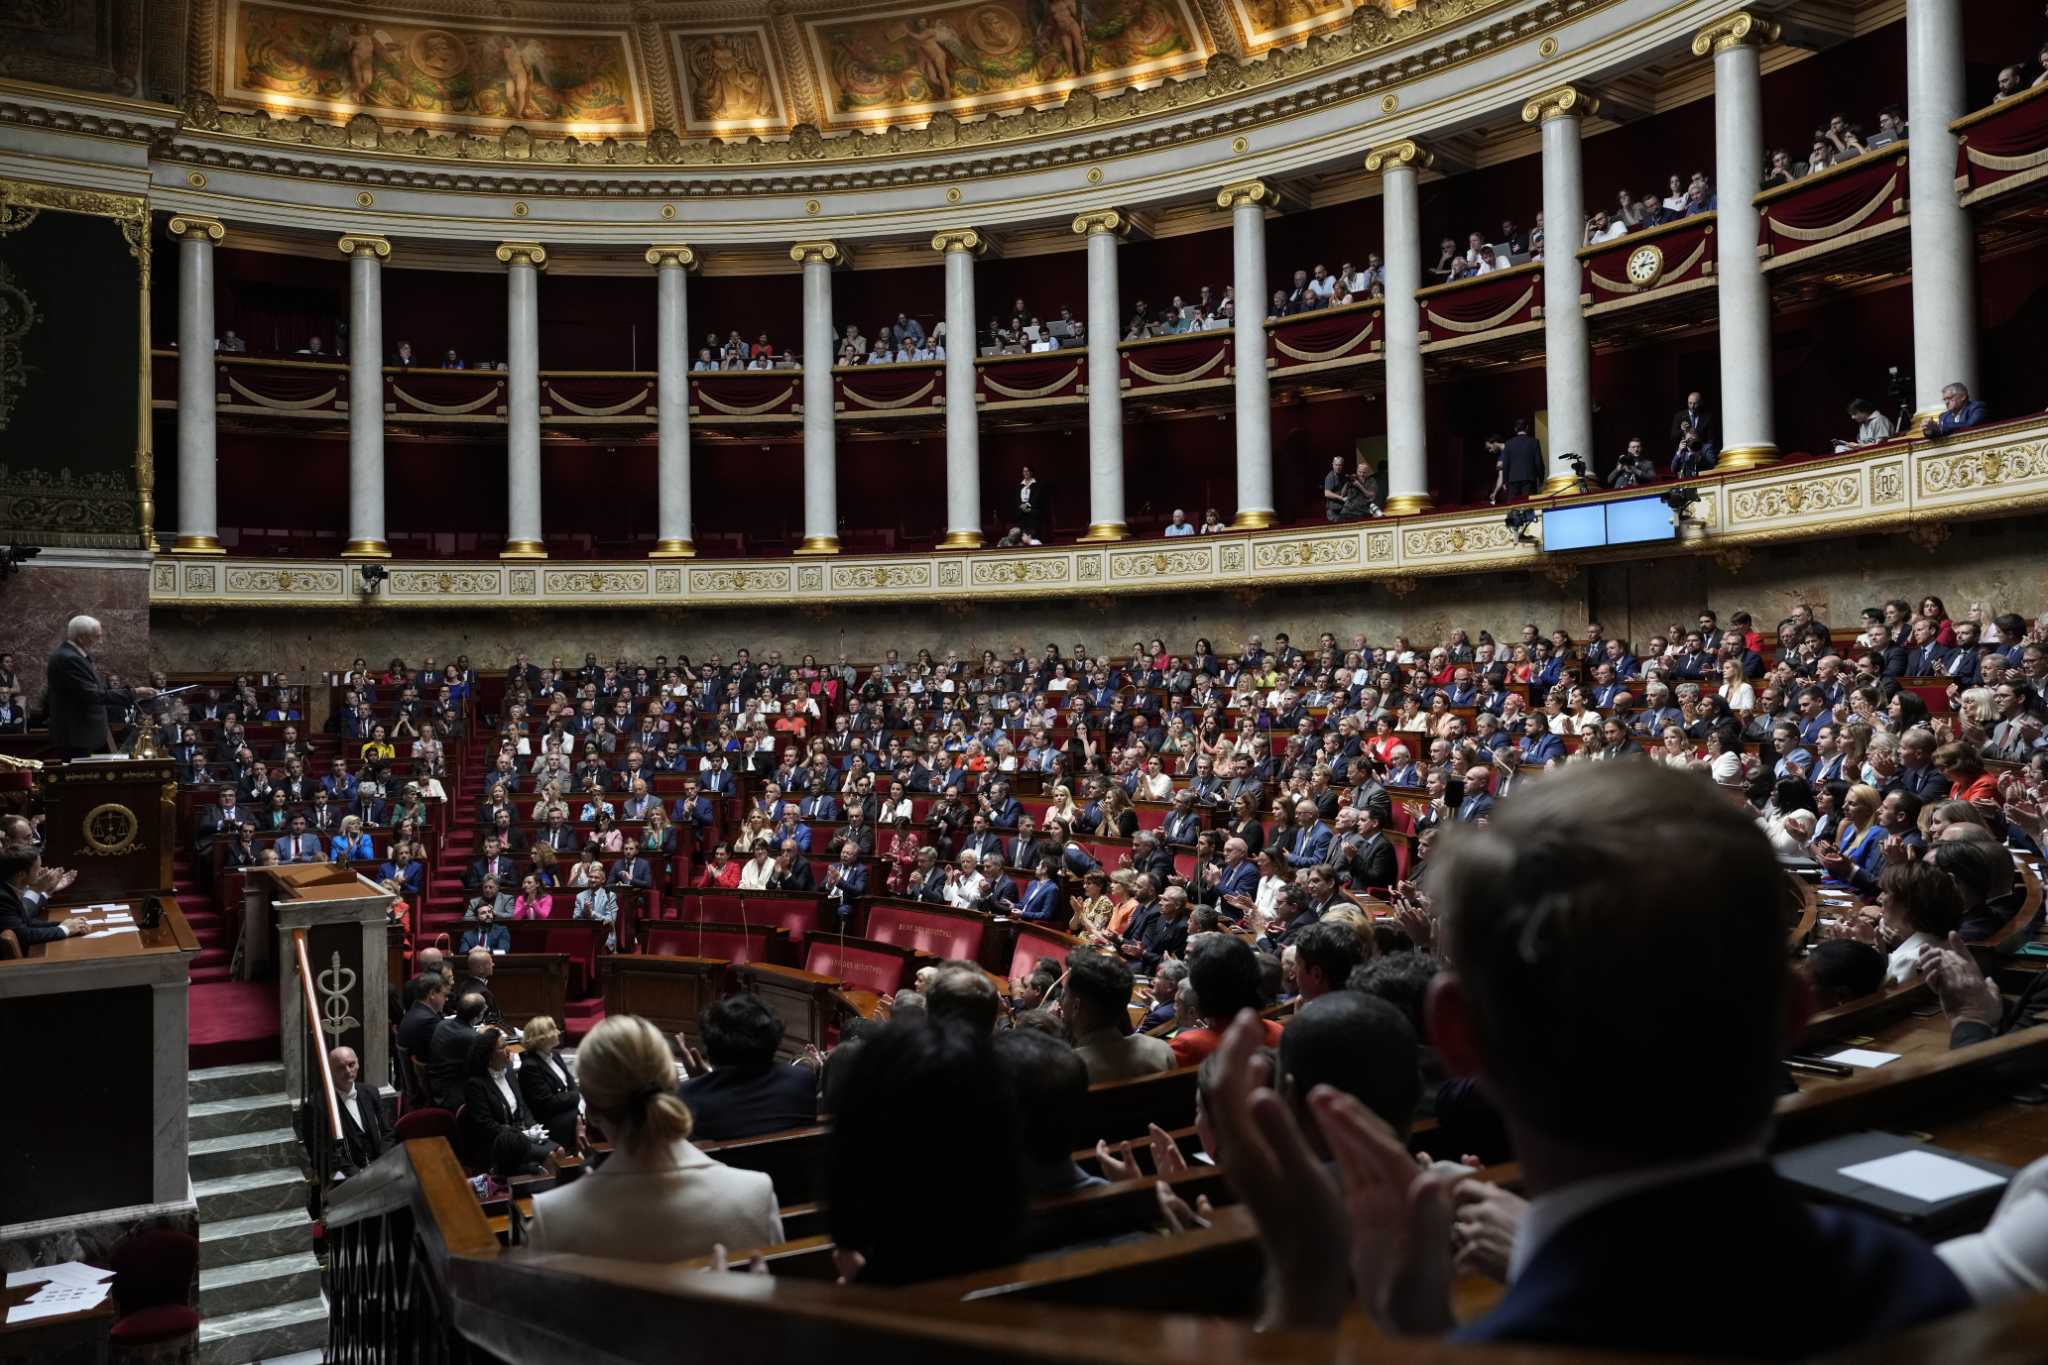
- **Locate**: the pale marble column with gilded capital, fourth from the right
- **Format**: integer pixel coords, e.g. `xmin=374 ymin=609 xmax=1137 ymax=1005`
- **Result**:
xmin=1366 ymin=139 xmax=1434 ymax=516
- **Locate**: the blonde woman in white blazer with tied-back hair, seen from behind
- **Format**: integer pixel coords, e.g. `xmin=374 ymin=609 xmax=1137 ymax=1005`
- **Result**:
xmin=528 ymin=1015 xmax=782 ymax=1261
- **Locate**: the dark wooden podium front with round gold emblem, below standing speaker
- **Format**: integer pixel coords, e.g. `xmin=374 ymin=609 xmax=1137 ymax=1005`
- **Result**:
xmin=41 ymin=757 xmax=178 ymax=900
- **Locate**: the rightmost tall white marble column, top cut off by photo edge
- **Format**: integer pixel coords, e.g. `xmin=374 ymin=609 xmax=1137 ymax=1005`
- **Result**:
xmin=1886 ymin=0 xmax=1982 ymax=426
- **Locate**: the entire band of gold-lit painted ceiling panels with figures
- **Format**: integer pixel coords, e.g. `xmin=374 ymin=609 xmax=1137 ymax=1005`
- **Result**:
xmin=184 ymin=0 xmax=1417 ymax=145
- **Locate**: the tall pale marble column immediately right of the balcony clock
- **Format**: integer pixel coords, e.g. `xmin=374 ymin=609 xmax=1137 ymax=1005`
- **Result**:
xmin=1692 ymin=10 xmax=1778 ymax=469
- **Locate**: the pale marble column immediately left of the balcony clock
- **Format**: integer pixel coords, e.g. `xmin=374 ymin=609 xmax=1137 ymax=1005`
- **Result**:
xmin=1522 ymin=86 xmax=1599 ymax=493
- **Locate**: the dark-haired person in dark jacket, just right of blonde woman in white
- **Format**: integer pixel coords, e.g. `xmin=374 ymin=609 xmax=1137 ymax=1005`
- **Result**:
xmin=680 ymin=995 xmax=817 ymax=1142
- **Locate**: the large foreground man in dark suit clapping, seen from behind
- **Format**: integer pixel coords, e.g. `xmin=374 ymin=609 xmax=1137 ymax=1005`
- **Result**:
xmin=1204 ymin=763 xmax=1970 ymax=1359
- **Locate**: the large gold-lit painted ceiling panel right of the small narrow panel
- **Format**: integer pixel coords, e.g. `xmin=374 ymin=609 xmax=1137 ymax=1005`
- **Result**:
xmin=805 ymin=0 xmax=1210 ymax=131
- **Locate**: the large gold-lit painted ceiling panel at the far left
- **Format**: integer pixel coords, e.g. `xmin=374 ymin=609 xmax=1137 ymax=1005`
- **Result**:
xmin=221 ymin=0 xmax=649 ymax=135
